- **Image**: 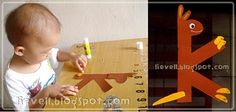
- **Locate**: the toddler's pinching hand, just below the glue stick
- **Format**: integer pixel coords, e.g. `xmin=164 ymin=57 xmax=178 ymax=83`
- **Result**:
xmin=72 ymin=55 xmax=87 ymax=73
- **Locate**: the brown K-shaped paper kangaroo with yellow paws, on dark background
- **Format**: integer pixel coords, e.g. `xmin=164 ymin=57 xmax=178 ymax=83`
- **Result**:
xmin=153 ymin=5 xmax=230 ymax=106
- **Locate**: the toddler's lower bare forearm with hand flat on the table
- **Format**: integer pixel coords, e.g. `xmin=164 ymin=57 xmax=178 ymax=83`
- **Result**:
xmin=28 ymin=84 xmax=79 ymax=110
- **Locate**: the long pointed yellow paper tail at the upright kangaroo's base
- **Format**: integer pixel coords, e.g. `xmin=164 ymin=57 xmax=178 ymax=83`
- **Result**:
xmin=152 ymin=91 xmax=185 ymax=106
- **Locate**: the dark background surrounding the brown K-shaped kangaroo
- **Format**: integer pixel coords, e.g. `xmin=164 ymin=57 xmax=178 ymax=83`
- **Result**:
xmin=148 ymin=3 xmax=232 ymax=108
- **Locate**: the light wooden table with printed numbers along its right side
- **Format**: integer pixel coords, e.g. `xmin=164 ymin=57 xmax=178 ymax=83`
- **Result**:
xmin=45 ymin=38 xmax=148 ymax=111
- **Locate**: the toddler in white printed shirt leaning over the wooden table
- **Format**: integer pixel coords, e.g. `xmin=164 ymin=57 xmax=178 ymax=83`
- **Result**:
xmin=4 ymin=3 xmax=87 ymax=110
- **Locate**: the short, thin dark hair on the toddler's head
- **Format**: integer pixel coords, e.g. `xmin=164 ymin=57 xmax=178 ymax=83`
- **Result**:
xmin=5 ymin=3 xmax=61 ymax=46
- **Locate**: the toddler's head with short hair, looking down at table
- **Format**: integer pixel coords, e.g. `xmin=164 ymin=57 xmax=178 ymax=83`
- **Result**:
xmin=5 ymin=3 xmax=60 ymax=64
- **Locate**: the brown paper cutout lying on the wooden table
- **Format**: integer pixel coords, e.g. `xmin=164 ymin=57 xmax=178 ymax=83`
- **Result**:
xmin=74 ymin=73 xmax=136 ymax=92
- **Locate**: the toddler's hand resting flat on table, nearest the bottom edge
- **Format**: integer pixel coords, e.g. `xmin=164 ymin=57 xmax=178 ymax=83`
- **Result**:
xmin=46 ymin=84 xmax=79 ymax=100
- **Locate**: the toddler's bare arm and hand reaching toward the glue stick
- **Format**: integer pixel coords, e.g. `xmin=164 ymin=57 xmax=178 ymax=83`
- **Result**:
xmin=57 ymin=51 xmax=87 ymax=72
